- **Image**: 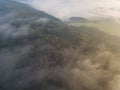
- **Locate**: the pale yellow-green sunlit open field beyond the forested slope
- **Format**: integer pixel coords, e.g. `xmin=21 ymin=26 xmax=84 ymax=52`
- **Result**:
xmin=69 ymin=21 xmax=120 ymax=37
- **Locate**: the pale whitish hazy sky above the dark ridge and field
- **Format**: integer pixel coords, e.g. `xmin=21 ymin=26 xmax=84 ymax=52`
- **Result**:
xmin=17 ymin=0 xmax=120 ymax=18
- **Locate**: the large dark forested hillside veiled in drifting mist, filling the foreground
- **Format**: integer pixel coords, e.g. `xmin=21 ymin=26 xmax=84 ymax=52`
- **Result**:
xmin=0 ymin=0 xmax=120 ymax=90
